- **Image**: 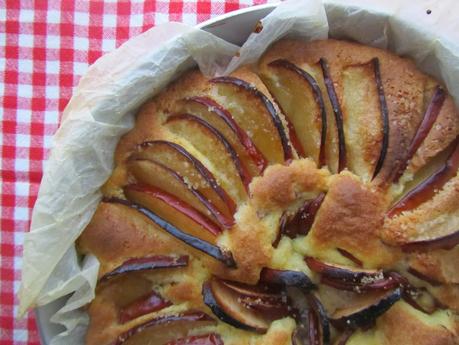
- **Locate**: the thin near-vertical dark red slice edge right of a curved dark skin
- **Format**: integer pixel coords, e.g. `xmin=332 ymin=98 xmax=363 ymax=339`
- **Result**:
xmin=319 ymin=58 xmax=347 ymax=172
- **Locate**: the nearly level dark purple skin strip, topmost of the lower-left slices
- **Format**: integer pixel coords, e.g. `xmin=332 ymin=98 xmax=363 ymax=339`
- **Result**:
xmin=99 ymin=255 xmax=188 ymax=282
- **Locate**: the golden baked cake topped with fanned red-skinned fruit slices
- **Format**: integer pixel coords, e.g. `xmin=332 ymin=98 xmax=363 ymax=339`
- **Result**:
xmin=78 ymin=40 xmax=459 ymax=345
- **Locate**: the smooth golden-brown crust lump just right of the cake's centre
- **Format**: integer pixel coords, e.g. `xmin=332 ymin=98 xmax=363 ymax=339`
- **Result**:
xmin=310 ymin=173 xmax=395 ymax=266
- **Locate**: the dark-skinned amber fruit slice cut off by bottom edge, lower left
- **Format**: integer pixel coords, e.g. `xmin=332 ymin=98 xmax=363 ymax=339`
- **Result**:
xmin=111 ymin=311 xmax=215 ymax=345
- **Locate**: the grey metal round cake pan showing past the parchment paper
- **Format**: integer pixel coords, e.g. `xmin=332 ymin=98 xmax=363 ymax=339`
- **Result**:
xmin=35 ymin=4 xmax=277 ymax=345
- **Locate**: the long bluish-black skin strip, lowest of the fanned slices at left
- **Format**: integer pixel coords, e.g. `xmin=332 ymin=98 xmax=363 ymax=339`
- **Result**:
xmin=104 ymin=198 xmax=236 ymax=268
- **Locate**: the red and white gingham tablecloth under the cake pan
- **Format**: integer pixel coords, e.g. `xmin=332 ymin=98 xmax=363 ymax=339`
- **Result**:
xmin=0 ymin=0 xmax=267 ymax=345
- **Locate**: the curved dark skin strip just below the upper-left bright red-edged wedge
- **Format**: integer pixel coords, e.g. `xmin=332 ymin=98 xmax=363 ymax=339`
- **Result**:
xmin=166 ymin=114 xmax=252 ymax=192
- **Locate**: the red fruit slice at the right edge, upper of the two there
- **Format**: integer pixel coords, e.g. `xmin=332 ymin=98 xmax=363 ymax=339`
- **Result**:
xmin=387 ymin=137 xmax=459 ymax=217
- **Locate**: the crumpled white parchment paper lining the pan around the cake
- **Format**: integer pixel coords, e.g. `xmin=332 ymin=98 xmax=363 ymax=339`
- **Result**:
xmin=19 ymin=0 xmax=459 ymax=345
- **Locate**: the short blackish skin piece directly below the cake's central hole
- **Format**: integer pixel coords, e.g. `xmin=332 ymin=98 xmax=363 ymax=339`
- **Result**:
xmin=260 ymin=268 xmax=315 ymax=291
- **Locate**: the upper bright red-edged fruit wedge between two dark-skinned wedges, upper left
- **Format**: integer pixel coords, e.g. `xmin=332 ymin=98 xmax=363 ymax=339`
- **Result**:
xmin=180 ymin=96 xmax=268 ymax=176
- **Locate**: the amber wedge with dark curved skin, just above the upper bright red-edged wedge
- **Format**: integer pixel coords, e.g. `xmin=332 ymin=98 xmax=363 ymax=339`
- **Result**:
xmin=210 ymin=76 xmax=293 ymax=164
